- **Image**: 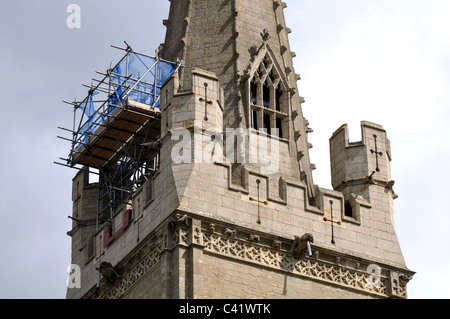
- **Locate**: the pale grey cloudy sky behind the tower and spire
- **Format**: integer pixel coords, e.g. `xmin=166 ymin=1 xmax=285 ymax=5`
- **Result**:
xmin=0 ymin=0 xmax=450 ymax=298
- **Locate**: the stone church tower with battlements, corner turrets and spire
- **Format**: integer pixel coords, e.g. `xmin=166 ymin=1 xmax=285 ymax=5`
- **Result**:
xmin=67 ymin=0 xmax=414 ymax=299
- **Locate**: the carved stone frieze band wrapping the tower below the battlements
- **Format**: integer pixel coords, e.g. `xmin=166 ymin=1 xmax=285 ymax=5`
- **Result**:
xmin=90 ymin=215 xmax=411 ymax=299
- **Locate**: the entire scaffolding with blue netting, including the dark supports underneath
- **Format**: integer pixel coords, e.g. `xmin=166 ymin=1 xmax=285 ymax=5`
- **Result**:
xmin=55 ymin=42 xmax=181 ymax=226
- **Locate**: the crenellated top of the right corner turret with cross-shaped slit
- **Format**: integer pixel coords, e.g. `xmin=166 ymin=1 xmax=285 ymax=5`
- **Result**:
xmin=330 ymin=121 xmax=393 ymax=191
